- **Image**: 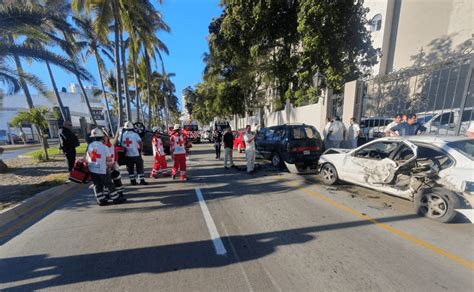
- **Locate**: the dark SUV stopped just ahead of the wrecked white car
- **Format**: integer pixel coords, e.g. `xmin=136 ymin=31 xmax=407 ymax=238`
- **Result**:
xmin=255 ymin=124 xmax=323 ymax=172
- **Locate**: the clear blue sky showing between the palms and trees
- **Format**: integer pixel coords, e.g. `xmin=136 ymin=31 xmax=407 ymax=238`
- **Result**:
xmin=11 ymin=0 xmax=221 ymax=110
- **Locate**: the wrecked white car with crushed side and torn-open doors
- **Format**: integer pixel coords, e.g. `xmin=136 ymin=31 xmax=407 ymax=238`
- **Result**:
xmin=319 ymin=136 xmax=474 ymax=222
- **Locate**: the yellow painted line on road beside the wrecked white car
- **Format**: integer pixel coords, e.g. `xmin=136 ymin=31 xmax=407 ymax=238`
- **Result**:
xmin=288 ymin=182 xmax=474 ymax=270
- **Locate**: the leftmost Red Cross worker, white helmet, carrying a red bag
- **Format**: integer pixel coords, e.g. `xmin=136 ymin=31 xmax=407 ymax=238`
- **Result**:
xmin=86 ymin=128 xmax=126 ymax=206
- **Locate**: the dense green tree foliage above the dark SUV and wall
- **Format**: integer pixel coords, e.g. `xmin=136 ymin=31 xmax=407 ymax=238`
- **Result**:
xmin=188 ymin=0 xmax=377 ymax=119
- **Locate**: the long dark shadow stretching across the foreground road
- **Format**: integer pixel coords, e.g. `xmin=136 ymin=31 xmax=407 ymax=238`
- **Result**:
xmin=0 ymin=215 xmax=419 ymax=291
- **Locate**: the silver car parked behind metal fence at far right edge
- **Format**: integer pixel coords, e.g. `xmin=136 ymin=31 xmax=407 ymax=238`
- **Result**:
xmin=416 ymin=107 xmax=474 ymax=135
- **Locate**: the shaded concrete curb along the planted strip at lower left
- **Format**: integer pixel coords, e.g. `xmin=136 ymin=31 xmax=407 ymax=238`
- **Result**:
xmin=0 ymin=182 xmax=88 ymax=230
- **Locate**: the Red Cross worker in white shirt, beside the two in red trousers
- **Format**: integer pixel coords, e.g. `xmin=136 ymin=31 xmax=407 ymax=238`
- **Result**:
xmin=119 ymin=122 xmax=148 ymax=185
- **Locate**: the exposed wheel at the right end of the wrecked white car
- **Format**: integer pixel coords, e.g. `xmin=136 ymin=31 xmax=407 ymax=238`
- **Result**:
xmin=414 ymin=188 xmax=461 ymax=223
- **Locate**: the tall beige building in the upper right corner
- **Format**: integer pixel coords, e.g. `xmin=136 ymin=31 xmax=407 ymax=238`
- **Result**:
xmin=364 ymin=0 xmax=474 ymax=75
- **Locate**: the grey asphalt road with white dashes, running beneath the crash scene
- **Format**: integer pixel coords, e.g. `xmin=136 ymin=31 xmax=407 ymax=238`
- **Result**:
xmin=0 ymin=144 xmax=474 ymax=291
